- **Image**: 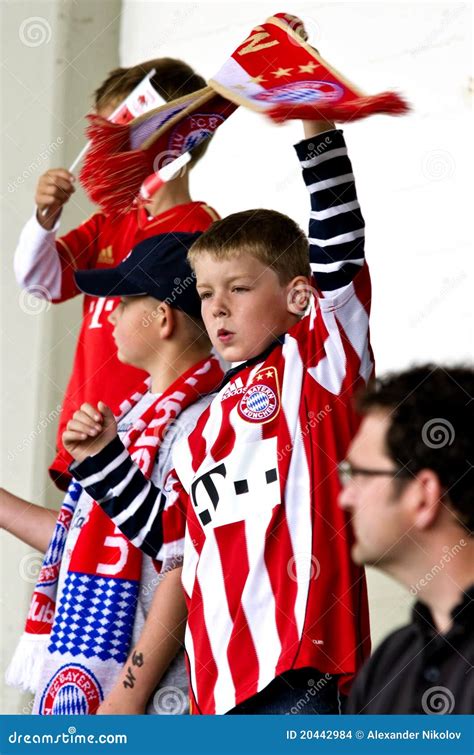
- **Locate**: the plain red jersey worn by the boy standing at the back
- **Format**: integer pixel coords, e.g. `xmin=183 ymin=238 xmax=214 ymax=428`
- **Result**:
xmin=49 ymin=202 xmax=218 ymax=488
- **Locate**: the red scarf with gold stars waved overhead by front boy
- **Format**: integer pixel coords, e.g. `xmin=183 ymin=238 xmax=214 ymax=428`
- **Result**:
xmin=80 ymin=13 xmax=408 ymax=213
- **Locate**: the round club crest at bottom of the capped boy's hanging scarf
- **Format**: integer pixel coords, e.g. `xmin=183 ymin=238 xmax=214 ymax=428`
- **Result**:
xmin=38 ymin=663 xmax=104 ymax=716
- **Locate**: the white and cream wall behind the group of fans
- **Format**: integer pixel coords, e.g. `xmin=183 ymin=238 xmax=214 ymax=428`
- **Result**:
xmin=0 ymin=0 xmax=472 ymax=712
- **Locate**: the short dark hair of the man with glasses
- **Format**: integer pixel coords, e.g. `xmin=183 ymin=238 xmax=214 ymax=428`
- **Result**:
xmin=357 ymin=364 xmax=474 ymax=534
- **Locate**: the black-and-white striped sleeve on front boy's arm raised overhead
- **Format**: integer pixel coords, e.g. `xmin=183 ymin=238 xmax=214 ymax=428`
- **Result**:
xmin=295 ymin=130 xmax=364 ymax=292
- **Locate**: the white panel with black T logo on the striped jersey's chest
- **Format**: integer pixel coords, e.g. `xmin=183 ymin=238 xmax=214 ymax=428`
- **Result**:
xmin=190 ymin=438 xmax=281 ymax=529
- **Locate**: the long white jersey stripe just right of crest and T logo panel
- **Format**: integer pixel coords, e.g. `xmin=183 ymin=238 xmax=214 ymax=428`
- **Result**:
xmin=282 ymin=336 xmax=313 ymax=637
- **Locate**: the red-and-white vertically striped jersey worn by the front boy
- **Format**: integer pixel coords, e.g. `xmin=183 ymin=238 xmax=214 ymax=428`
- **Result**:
xmin=170 ymin=266 xmax=373 ymax=714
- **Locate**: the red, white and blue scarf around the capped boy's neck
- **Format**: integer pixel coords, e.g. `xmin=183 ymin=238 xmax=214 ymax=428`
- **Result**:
xmin=6 ymin=357 xmax=223 ymax=715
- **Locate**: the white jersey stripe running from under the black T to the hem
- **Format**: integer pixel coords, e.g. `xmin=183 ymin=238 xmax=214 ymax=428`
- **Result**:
xmin=196 ymin=527 xmax=235 ymax=713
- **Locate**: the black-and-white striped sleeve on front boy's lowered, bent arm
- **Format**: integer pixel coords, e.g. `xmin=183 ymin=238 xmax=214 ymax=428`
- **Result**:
xmin=69 ymin=435 xmax=166 ymax=558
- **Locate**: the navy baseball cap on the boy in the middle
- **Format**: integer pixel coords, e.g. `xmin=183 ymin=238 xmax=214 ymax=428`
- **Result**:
xmin=74 ymin=233 xmax=202 ymax=317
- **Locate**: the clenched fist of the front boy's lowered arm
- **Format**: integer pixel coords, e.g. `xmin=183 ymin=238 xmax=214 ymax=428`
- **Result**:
xmin=63 ymin=401 xmax=117 ymax=461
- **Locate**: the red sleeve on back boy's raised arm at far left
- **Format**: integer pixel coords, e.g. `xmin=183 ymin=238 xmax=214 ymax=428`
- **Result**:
xmin=54 ymin=212 xmax=105 ymax=303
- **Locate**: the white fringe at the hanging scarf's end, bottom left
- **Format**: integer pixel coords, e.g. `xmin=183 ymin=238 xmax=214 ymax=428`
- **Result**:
xmin=5 ymin=632 xmax=49 ymax=694
